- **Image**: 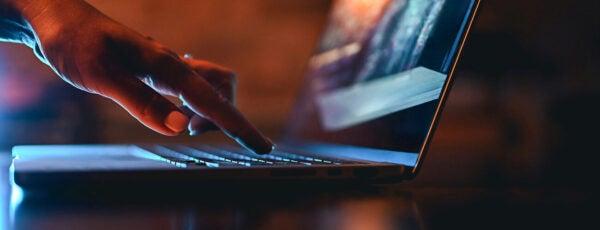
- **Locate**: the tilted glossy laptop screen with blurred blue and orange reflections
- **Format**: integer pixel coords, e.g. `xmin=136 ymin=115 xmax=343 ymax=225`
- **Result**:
xmin=284 ymin=0 xmax=475 ymax=153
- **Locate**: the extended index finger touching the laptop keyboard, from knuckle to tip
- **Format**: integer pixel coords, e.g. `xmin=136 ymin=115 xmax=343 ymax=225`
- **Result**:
xmin=139 ymin=49 xmax=273 ymax=154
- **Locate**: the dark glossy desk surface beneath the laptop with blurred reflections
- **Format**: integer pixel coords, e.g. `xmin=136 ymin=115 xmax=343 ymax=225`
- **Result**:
xmin=0 ymin=154 xmax=597 ymax=230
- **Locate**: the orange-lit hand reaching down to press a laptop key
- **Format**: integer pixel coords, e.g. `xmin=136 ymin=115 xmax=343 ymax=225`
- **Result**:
xmin=8 ymin=0 xmax=273 ymax=153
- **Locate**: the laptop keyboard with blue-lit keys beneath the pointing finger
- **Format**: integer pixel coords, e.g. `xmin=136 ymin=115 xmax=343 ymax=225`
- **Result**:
xmin=137 ymin=144 xmax=361 ymax=168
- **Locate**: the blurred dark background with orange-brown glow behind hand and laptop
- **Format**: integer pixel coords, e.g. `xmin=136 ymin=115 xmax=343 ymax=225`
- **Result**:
xmin=0 ymin=0 xmax=600 ymax=187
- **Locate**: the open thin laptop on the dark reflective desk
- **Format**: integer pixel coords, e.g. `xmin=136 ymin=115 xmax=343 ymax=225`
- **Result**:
xmin=11 ymin=0 xmax=479 ymax=190
